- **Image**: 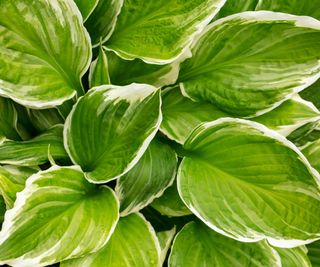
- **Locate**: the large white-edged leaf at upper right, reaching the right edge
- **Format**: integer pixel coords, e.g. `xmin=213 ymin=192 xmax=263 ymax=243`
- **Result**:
xmin=178 ymin=11 xmax=320 ymax=116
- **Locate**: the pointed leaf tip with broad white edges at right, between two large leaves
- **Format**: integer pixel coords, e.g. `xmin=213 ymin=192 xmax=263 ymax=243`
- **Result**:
xmin=252 ymin=95 xmax=320 ymax=136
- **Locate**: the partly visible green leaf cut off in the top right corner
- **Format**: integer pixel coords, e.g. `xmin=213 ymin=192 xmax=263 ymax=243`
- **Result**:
xmin=256 ymin=0 xmax=320 ymax=20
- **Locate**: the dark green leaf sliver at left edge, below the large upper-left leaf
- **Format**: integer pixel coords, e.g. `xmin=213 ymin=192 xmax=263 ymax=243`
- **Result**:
xmin=0 ymin=97 xmax=21 ymax=140
